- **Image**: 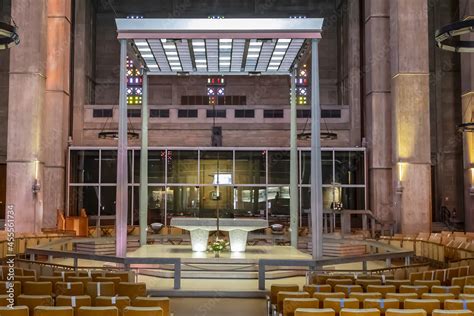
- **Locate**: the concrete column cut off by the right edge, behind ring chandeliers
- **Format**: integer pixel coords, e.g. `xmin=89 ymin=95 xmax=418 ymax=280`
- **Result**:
xmin=459 ymin=0 xmax=474 ymax=232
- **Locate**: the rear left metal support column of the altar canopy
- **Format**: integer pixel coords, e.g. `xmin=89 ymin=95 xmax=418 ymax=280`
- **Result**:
xmin=140 ymin=70 xmax=148 ymax=246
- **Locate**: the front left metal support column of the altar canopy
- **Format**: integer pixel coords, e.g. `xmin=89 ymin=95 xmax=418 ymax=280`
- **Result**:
xmin=115 ymin=39 xmax=128 ymax=257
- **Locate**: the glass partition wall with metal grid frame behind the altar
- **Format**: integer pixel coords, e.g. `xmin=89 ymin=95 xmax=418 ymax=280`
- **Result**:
xmin=67 ymin=147 xmax=367 ymax=226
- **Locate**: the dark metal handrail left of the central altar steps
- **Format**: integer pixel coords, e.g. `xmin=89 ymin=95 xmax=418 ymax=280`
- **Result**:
xmin=25 ymin=248 xmax=181 ymax=289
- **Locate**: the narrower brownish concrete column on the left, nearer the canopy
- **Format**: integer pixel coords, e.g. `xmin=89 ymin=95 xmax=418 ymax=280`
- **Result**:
xmin=42 ymin=0 xmax=71 ymax=227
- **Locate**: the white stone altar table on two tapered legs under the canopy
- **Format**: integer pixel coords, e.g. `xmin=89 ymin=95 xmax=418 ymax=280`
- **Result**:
xmin=171 ymin=217 xmax=268 ymax=252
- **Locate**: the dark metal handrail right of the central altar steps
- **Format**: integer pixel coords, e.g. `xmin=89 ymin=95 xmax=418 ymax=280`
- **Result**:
xmin=258 ymin=251 xmax=415 ymax=290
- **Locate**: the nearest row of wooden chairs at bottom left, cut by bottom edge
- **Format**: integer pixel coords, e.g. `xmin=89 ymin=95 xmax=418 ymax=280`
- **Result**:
xmin=0 ymin=306 xmax=165 ymax=316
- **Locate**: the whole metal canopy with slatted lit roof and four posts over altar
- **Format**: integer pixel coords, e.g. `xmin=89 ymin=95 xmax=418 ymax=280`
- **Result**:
xmin=116 ymin=18 xmax=323 ymax=259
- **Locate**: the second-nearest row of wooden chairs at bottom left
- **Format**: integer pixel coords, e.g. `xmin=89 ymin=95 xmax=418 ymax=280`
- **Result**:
xmin=0 ymin=294 xmax=170 ymax=316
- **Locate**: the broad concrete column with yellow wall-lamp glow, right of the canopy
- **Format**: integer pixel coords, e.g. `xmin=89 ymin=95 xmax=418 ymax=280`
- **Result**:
xmin=390 ymin=0 xmax=431 ymax=234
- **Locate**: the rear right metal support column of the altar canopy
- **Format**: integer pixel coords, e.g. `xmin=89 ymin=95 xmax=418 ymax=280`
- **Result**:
xmin=290 ymin=67 xmax=298 ymax=248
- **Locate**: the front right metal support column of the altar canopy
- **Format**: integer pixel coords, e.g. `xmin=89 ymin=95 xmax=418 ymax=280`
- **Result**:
xmin=311 ymin=39 xmax=323 ymax=259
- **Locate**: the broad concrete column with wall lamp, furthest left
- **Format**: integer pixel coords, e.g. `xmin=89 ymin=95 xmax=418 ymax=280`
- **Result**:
xmin=6 ymin=0 xmax=47 ymax=233
